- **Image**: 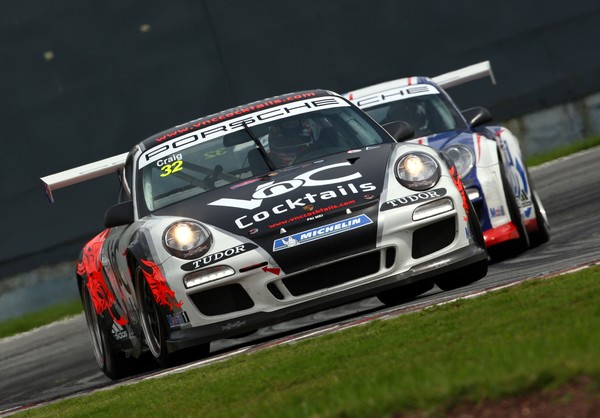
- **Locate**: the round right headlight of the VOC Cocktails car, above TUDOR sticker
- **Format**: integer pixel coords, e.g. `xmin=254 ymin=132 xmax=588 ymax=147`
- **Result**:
xmin=396 ymin=152 xmax=440 ymax=190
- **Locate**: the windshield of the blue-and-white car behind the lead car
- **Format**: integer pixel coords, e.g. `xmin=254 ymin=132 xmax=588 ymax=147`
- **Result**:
xmin=363 ymin=85 xmax=466 ymax=137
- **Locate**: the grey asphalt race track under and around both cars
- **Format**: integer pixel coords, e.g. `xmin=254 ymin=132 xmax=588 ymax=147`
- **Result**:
xmin=0 ymin=147 xmax=600 ymax=415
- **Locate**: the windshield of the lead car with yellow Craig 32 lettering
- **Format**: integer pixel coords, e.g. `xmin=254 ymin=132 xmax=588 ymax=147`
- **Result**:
xmin=137 ymin=101 xmax=393 ymax=211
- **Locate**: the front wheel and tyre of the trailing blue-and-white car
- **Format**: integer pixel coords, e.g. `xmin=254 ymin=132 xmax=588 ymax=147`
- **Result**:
xmin=488 ymin=163 xmax=529 ymax=261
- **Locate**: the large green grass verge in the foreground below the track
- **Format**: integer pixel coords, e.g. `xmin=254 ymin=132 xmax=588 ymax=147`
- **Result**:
xmin=24 ymin=267 xmax=600 ymax=418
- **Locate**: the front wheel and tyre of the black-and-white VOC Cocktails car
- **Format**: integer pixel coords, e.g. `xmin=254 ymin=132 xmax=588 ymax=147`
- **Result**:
xmin=135 ymin=267 xmax=210 ymax=368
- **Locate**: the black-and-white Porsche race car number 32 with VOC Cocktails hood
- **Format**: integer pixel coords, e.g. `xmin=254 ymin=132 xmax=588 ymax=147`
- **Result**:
xmin=42 ymin=90 xmax=487 ymax=378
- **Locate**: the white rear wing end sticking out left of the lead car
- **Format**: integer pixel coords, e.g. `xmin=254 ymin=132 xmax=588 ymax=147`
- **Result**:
xmin=40 ymin=152 xmax=129 ymax=203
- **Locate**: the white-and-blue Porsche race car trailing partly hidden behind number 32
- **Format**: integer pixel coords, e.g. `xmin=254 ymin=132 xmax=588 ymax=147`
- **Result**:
xmin=345 ymin=61 xmax=550 ymax=259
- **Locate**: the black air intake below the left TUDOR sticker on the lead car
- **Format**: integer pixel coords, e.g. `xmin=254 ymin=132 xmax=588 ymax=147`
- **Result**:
xmin=190 ymin=283 xmax=254 ymax=316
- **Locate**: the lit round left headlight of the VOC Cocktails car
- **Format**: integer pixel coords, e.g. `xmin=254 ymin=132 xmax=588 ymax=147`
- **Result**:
xmin=164 ymin=221 xmax=212 ymax=258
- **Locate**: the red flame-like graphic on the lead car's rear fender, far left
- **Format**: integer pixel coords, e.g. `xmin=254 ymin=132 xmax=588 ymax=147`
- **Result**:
xmin=77 ymin=229 xmax=129 ymax=326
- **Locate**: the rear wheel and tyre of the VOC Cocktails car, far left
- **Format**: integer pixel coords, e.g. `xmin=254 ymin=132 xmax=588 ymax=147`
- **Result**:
xmin=80 ymin=284 xmax=139 ymax=380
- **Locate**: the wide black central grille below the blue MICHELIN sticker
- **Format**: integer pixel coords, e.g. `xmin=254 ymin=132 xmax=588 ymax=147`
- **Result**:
xmin=282 ymin=248 xmax=386 ymax=296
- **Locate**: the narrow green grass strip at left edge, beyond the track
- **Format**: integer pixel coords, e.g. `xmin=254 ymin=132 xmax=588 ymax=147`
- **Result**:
xmin=0 ymin=299 xmax=83 ymax=338
